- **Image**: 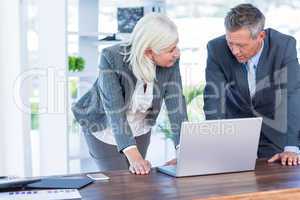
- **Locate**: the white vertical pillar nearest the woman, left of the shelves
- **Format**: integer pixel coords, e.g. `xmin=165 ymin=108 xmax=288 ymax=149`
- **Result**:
xmin=38 ymin=0 xmax=68 ymax=175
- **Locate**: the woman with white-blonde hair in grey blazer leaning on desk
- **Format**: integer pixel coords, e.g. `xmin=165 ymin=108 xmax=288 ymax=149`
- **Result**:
xmin=72 ymin=13 xmax=187 ymax=174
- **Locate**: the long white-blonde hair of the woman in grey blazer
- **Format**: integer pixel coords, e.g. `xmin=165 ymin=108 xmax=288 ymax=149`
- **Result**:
xmin=122 ymin=13 xmax=178 ymax=82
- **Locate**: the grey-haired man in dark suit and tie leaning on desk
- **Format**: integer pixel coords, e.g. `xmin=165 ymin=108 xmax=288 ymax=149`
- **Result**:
xmin=204 ymin=4 xmax=300 ymax=165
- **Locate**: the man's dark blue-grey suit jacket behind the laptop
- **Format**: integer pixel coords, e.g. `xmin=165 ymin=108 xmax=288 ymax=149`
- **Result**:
xmin=204 ymin=29 xmax=300 ymax=156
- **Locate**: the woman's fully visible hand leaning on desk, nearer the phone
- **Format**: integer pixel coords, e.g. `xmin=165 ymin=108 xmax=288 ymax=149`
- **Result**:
xmin=124 ymin=148 xmax=151 ymax=175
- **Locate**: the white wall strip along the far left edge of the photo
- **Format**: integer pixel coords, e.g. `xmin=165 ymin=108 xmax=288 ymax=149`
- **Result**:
xmin=0 ymin=0 xmax=25 ymax=176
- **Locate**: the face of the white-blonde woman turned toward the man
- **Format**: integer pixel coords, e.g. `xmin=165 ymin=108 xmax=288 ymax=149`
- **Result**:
xmin=145 ymin=42 xmax=180 ymax=67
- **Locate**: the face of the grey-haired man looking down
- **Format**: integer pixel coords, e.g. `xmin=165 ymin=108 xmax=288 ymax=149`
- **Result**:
xmin=226 ymin=28 xmax=265 ymax=63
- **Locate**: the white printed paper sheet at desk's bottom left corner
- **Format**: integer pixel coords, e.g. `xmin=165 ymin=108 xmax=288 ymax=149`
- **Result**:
xmin=0 ymin=189 xmax=81 ymax=200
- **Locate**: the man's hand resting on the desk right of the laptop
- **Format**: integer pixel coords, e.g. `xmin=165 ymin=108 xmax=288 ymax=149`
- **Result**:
xmin=268 ymin=151 xmax=300 ymax=165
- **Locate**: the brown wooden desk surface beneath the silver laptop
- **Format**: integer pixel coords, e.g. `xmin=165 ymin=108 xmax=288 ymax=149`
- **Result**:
xmin=80 ymin=160 xmax=300 ymax=200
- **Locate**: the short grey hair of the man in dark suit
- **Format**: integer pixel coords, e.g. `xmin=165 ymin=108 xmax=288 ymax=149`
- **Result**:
xmin=224 ymin=4 xmax=265 ymax=38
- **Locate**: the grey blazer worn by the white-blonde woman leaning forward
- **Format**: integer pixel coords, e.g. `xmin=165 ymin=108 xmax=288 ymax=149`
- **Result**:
xmin=72 ymin=45 xmax=187 ymax=151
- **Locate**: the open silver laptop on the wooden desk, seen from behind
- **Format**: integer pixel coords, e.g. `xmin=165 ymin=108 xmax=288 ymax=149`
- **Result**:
xmin=157 ymin=117 xmax=262 ymax=177
